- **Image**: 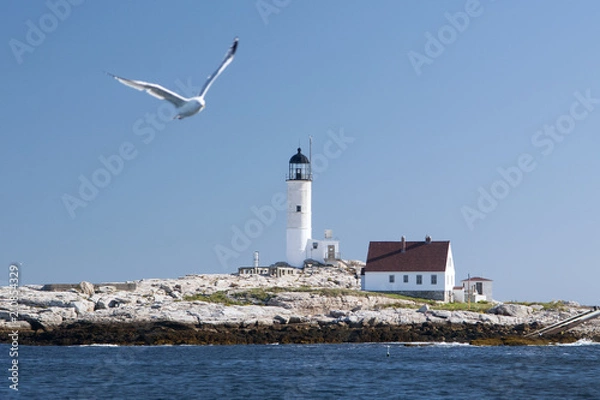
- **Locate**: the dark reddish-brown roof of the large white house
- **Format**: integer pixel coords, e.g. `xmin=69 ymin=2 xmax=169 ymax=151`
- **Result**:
xmin=365 ymin=241 xmax=450 ymax=272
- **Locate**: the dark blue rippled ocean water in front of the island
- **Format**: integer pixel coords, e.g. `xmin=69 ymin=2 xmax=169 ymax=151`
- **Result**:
xmin=0 ymin=343 xmax=600 ymax=400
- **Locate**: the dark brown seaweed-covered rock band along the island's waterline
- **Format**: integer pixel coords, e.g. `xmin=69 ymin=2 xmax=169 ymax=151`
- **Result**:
xmin=3 ymin=321 xmax=584 ymax=346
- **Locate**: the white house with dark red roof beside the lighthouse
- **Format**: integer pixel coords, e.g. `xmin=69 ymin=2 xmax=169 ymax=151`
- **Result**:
xmin=361 ymin=236 xmax=455 ymax=301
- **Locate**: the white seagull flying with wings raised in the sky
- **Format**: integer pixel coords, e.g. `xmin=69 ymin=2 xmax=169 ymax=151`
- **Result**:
xmin=107 ymin=37 xmax=238 ymax=119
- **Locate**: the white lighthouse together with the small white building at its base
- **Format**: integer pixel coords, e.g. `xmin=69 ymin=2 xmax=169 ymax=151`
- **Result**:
xmin=286 ymin=148 xmax=340 ymax=267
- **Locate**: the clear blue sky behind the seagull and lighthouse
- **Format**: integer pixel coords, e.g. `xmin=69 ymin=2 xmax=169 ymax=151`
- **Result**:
xmin=0 ymin=0 xmax=600 ymax=304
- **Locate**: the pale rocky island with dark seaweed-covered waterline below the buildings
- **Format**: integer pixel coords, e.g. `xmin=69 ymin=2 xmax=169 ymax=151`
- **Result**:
xmin=0 ymin=262 xmax=600 ymax=345
